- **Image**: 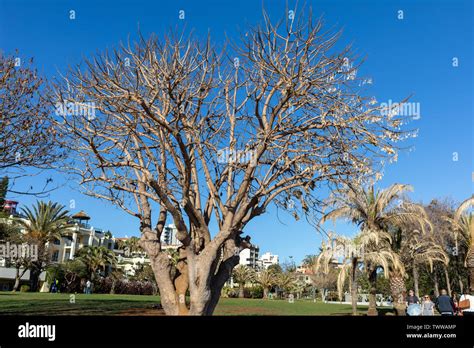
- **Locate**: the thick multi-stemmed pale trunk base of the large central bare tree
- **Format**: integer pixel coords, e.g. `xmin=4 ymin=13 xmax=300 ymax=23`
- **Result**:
xmin=141 ymin=227 xmax=239 ymax=316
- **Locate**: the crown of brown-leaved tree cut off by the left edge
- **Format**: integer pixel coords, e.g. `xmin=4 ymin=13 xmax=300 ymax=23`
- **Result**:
xmin=0 ymin=53 xmax=61 ymax=194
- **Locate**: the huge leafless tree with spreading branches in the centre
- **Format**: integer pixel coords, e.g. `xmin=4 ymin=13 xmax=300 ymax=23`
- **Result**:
xmin=52 ymin=10 xmax=414 ymax=315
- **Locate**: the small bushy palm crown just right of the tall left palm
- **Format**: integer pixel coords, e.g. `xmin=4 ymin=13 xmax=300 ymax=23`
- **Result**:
xmin=76 ymin=246 xmax=117 ymax=280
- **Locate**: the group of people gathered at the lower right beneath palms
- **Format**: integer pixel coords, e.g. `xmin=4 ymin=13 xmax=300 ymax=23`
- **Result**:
xmin=406 ymin=289 xmax=474 ymax=316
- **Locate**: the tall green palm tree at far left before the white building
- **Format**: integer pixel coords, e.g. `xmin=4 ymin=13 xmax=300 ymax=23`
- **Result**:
xmin=17 ymin=201 xmax=71 ymax=291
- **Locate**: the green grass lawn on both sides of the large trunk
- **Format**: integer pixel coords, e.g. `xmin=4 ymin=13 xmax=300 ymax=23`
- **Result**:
xmin=0 ymin=292 xmax=374 ymax=315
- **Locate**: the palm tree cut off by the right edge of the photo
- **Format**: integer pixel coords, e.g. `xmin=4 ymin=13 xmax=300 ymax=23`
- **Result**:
xmin=446 ymin=196 xmax=474 ymax=292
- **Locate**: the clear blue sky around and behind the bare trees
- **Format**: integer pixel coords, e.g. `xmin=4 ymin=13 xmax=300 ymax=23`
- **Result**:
xmin=0 ymin=0 xmax=474 ymax=262
